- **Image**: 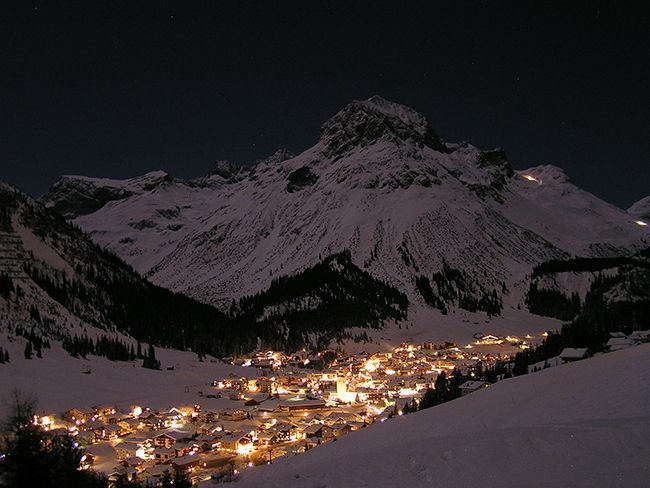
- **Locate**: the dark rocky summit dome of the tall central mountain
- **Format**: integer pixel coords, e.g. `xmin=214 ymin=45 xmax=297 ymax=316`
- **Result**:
xmin=320 ymin=95 xmax=447 ymax=158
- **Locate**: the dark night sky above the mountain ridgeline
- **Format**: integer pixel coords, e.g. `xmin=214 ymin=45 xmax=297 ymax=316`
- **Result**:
xmin=0 ymin=0 xmax=650 ymax=207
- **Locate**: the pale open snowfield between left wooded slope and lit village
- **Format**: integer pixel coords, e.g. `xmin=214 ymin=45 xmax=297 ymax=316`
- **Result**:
xmin=0 ymin=336 xmax=252 ymax=419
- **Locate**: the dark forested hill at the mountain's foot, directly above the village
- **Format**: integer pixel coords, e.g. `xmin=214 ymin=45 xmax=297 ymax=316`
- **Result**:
xmin=231 ymin=252 xmax=408 ymax=350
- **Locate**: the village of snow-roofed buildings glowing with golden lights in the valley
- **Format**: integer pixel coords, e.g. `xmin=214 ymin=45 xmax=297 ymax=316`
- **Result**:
xmin=27 ymin=336 xmax=536 ymax=484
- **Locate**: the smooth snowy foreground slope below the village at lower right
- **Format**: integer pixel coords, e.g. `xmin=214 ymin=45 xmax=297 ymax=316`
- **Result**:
xmin=232 ymin=344 xmax=650 ymax=488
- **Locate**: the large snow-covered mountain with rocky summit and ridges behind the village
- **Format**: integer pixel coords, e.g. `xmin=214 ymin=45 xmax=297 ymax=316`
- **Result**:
xmin=43 ymin=96 xmax=648 ymax=328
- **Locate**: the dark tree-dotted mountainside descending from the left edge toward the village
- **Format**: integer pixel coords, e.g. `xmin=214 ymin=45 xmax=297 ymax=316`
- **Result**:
xmin=0 ymin=182 xmax=243 ymax=353
